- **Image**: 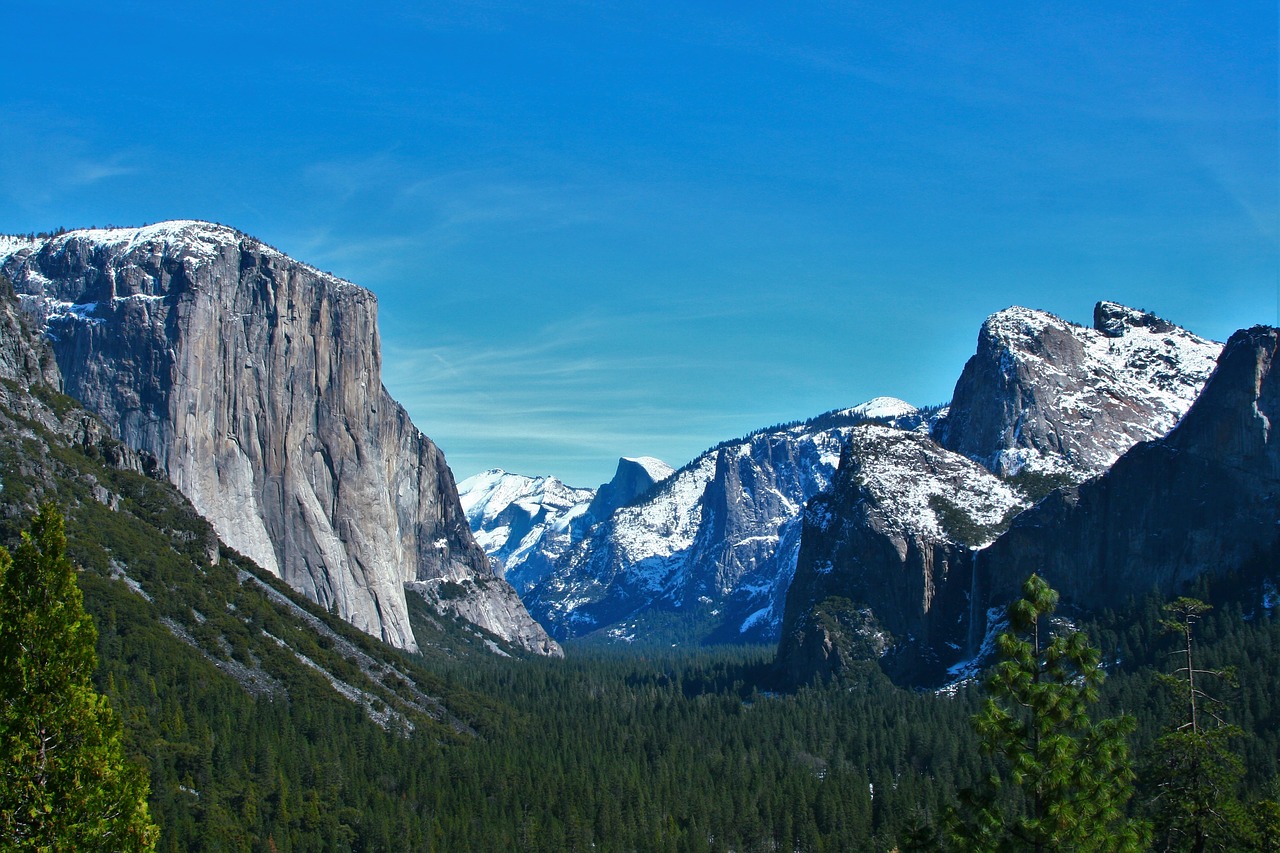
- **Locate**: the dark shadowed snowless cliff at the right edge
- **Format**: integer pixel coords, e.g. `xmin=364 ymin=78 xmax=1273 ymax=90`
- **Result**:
xmin=975 ymin=327 xmax=1280 ymax=617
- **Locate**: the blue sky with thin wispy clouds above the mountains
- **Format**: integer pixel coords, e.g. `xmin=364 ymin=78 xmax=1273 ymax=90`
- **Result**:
xmin=0 ymin=0 xmax=1280 ymax=485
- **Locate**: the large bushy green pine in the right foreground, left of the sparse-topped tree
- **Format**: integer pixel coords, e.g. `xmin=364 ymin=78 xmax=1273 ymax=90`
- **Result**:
xmin=947 ymin=575 xmax=1144 ymax=853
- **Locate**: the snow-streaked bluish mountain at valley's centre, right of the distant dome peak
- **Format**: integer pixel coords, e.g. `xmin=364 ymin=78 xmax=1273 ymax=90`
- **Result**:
xmin=525 ymin=401 xmax=923 ymax=642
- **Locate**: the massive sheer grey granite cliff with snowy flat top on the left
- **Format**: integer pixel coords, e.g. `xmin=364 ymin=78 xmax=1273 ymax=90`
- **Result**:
xmin=0 ymin=222 xmax=558 ymax=649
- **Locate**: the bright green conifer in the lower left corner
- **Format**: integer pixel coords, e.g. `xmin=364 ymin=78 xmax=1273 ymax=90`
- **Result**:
xmin=0 ymin=503 xmax=157 ymax=850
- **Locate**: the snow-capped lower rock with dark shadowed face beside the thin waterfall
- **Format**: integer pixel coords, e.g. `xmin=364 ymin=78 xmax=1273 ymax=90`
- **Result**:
xmin=778 ymin=424 xmax=1027 ymax=683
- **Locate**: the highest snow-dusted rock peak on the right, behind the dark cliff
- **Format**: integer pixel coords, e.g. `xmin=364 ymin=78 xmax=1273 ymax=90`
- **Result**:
xmin=934 ymin=302 xmax=1221 ymax=480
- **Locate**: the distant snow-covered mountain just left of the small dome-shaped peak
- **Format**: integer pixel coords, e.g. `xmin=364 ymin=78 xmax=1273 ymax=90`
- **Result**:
xmin=458 ymin=469 xmax=595 ymax=592
